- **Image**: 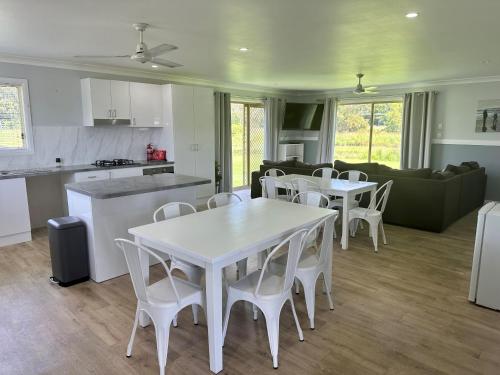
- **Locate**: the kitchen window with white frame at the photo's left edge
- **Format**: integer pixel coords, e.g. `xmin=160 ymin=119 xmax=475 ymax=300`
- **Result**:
xmin=0 ymin=78 xmax=33 ymax=155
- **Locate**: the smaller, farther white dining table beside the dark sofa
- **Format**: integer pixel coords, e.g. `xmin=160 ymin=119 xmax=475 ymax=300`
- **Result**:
xmin=275 ymin=174 xmax=377 ymax=250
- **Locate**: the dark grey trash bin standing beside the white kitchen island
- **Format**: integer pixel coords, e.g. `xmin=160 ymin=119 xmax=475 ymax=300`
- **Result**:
xmin=47 ymin=216 xmax=89 ymax=287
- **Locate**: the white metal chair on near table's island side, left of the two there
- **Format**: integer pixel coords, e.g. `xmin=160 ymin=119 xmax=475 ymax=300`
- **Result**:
xmin=153 ymin=202 xmax=203 ymax=327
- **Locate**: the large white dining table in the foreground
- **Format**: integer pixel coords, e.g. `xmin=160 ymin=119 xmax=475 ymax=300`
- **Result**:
xmin=129 ymin=198 xmax=338 ymax=373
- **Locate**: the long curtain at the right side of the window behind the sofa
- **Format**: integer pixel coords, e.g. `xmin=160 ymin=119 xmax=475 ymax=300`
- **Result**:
xmin=401 ymin=91 xmax=437 ymax=169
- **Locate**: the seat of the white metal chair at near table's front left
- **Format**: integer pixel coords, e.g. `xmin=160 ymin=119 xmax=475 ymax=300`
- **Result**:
xmin=146 ymin=277 xmax=202 ymax=305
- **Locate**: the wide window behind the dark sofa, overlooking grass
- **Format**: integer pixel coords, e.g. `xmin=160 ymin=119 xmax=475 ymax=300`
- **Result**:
xmin=334 ymin=101 xmax=403 ymax=168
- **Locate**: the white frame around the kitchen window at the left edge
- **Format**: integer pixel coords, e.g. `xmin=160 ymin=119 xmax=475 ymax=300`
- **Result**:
xmin=0 ymin=77 xmax=34 ymax=156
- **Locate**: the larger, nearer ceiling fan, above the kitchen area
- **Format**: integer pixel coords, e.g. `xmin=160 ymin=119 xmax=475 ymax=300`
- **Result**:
xmin=74 ymin=23 xmax=182 ymax=68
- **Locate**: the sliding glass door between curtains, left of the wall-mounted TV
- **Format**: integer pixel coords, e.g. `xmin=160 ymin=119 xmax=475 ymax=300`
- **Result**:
xmin=231 ymin=102 xmax=264 ymax=189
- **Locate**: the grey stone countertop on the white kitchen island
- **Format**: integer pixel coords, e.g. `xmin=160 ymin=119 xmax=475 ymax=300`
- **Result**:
xmin=65 ymin=173 xmax=211 ymax=199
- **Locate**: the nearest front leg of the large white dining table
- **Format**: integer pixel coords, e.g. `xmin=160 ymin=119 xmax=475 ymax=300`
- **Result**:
xmin=205 ymin=264 xmax=223 ymax=374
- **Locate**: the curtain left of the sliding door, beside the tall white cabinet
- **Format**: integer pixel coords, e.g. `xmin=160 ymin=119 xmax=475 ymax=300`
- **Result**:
xmin=214 ymin=92 xmax=233 ymax=192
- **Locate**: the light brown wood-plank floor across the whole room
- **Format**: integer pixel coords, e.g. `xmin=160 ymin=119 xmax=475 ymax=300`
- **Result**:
xmin=0 ymin=215 xmax=500 ymax=375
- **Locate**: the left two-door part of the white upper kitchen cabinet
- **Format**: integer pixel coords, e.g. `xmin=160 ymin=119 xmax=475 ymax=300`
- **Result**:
xmin=81 ymin=78 xmax=130 ymax=126
